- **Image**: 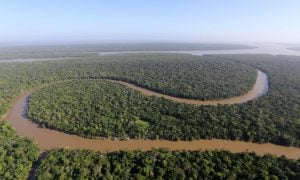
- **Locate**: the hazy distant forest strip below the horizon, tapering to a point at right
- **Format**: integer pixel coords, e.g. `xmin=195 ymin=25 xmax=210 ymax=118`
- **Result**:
xmin=0 ymin=43 xmax=255 ymax=60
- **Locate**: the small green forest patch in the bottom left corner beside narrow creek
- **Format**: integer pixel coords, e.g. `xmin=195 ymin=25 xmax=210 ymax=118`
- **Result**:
xmin=0 ymin=121 xmax=39 ymax=180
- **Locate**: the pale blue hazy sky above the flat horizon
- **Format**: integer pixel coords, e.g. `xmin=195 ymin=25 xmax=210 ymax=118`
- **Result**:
xmin=0 ymin=0 xmax=300 ymax=43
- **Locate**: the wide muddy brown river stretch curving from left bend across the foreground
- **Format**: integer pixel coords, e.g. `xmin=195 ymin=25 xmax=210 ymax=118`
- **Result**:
xmin=5 ymin=74 xmax=300 ymax=159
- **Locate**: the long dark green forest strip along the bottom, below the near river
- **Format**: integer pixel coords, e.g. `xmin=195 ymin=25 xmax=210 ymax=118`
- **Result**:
xmin=36 ymin=149 xmax=300 ymax=180
